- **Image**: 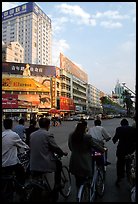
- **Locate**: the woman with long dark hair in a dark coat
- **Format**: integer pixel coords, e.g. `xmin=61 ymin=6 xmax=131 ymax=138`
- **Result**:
xmin=68 ymin=121 xmax=105 ymax=195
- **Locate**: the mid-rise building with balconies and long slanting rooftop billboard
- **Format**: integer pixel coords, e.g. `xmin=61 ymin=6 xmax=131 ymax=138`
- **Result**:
xmin=60 ymin=53 xmax=88 ymax=113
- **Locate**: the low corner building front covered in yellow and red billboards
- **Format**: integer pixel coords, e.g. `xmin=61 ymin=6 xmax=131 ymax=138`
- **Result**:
xmin=2 ymin=62 xmax=60 ymax=118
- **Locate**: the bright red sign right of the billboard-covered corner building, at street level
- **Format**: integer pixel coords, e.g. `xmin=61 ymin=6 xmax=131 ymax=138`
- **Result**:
xmin=60 ymin=96 xmax=75 ymax=110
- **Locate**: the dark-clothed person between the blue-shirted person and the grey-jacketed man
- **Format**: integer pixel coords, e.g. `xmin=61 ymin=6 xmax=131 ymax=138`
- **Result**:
xmin=25 ymin=119 xmax=39 ymax=146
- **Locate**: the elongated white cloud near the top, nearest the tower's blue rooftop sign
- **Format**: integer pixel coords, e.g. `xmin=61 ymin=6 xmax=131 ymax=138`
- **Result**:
xmin=56 ymin=3 xmax=96 ymax=26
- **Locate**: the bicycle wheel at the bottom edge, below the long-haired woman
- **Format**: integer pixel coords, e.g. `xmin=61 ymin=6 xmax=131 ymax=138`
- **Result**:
xmin=78 ymin=183 xmax=90 ymax=202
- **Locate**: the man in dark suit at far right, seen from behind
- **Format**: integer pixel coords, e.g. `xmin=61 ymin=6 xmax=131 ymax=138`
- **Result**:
xmin=112 ymin=118 xmax=136 ymax=186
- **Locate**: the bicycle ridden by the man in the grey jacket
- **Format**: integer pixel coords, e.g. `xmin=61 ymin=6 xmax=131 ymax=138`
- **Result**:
xmin=25 ymin=155 xmax=71 ymax=202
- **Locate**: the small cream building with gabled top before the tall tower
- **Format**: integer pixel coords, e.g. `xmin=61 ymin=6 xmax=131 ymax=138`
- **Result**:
xmin=2 ymin=42 xmax=24 ymax=63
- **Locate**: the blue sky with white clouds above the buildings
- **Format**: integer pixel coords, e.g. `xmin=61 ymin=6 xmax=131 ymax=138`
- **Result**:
xmin=2 ymin=2 xmax=136 ymax=94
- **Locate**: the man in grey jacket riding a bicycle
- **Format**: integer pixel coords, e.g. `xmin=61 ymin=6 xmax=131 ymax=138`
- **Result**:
xmin=30 ymin=118 xmax=67 ymax=200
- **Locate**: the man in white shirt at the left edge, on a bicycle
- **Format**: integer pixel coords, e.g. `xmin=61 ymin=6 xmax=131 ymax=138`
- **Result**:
xmin=2 ymin=118 xmax=29 ymax=184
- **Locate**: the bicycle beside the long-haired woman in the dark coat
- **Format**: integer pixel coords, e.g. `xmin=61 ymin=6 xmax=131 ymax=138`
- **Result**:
xmin=77 ymin=151 xmax=106 ymax=202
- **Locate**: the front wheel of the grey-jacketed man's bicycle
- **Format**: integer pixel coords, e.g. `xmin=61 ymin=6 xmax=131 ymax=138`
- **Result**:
xmin=60 ymin=166 xmax=71 ymax=198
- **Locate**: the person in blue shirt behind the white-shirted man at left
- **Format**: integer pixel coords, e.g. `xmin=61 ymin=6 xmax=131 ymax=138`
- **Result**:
xmin=13 ymin=118 xmax=26 ymax=141
